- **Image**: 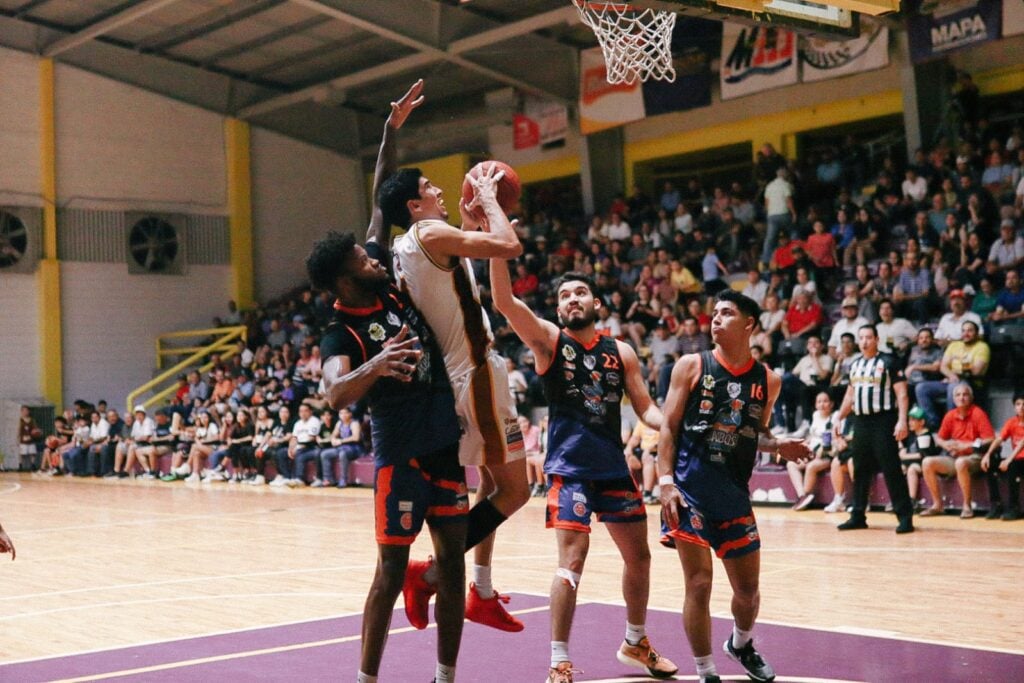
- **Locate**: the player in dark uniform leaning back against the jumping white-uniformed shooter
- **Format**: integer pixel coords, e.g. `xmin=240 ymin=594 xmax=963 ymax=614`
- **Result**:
xmin=306 ymin=82 xmax=469 ymax=683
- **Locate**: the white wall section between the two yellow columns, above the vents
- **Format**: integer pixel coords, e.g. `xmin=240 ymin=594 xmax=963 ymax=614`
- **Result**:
xmin=54 ymin=65 xmax=227 ymax=214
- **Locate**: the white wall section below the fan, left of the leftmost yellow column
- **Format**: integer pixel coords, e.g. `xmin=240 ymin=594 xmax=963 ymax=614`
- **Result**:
xmin=0 ymin=273 xmax=40 ymax=398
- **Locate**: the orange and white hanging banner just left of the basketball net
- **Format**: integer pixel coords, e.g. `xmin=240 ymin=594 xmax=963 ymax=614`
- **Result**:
xmin=580 ymin=47 xmax=644 ymax=135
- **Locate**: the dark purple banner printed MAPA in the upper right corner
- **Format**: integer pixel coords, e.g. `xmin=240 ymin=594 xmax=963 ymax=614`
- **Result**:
xmin=906 ymin=0 xmax=1002 ymax=63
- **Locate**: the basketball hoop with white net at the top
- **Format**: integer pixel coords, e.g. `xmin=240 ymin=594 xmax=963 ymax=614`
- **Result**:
xmin=572 ymin=0 xmax=676 ymax=84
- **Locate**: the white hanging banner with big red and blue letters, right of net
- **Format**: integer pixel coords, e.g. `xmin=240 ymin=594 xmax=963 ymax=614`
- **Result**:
xmin=720 ymin=24 xmax=798 ymax=99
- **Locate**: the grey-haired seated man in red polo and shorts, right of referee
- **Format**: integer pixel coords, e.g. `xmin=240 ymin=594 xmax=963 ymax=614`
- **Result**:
xmin=921 ymin=385 xmax=995 ymax=519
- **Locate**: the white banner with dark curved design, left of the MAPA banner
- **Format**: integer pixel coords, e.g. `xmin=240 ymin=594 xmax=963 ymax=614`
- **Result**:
xmin=800 ymin=16 xmax=889 ymax=82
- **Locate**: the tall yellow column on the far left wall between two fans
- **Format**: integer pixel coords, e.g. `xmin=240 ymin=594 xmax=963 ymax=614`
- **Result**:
xmin=36 ymin=59 xmax=63 ymax=411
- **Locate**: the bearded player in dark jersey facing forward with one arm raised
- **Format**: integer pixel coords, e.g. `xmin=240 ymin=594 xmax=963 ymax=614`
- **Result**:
xmin=490 ymin=258 xmax=677 ymax=683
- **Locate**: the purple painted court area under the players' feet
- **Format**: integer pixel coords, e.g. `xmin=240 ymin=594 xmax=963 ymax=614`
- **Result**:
xmin=0 ymin=594 xmax=1024 ymax=683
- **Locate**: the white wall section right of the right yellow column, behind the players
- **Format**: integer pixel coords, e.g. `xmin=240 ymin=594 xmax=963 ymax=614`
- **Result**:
xmin=252 ymin=128 xmax=368 ymax=301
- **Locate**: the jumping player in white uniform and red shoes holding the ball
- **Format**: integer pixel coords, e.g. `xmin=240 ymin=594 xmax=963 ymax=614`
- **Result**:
xmin=379 ymin=87 xmax=529 ymax=631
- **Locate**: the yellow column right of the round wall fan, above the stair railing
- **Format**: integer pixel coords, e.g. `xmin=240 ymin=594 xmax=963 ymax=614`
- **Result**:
xmin=224 ymin=119 xmax=256 ymax=308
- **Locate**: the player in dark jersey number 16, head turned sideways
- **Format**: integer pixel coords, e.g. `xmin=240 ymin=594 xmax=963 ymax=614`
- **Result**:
xmin=657 ymin=290 xmax=811 ymax=683
